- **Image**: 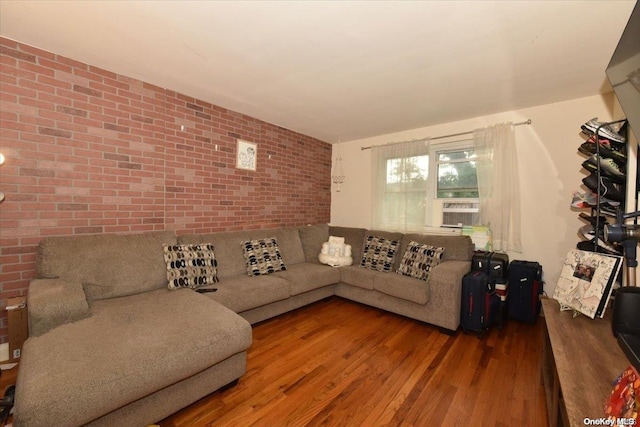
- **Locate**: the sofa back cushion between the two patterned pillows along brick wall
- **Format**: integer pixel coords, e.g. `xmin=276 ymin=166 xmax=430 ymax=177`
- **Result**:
xmin=178 ymin=231 xmax=251 ymax=280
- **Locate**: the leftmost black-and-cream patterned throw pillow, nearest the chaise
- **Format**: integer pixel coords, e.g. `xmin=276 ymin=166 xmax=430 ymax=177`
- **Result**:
xmin=163 ymin=243 xmax=218 ymax=289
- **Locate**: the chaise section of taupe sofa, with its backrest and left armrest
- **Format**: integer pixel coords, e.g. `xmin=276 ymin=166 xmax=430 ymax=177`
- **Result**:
xmin=14 ymin=231 xmax=251 ymax=426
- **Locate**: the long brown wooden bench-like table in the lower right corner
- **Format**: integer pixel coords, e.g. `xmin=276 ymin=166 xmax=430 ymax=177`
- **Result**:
xmin=542 ymin=298 xmax=630 ymax=427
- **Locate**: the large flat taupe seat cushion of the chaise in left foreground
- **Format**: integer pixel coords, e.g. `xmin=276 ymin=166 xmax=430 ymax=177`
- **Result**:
xmin=16 ymin=290 xmax=252 ymax=426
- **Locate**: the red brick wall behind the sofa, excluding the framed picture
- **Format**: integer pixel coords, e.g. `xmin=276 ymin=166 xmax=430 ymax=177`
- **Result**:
xmin=0 ymin=38 xmax=331 ymax=342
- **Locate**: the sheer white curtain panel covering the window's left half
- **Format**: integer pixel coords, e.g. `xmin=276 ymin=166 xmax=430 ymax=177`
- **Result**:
xmin=371 ymin=139 xmax=429 ymax=231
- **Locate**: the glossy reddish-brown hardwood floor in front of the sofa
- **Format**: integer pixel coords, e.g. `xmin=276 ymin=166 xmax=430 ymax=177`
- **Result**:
xmin=159 ymin=297 xmax=547 ymax=427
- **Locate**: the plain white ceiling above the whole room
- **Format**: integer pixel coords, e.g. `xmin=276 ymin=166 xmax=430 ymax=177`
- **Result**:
xmin=0 ymin=0 xmax=635 ymax=142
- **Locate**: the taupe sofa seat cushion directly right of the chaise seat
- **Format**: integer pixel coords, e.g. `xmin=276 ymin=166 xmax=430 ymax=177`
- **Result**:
xmin=203 ymin=274 xmax=291 ymax=313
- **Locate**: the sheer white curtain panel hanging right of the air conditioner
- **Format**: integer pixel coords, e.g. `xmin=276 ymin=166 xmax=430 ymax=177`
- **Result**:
xmin=473 ymin=123 xmax=522 ymax=252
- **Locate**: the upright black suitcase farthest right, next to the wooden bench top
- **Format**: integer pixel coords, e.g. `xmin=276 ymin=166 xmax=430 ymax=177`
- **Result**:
xmin=507 ymin=260 xmax=544 ymax=322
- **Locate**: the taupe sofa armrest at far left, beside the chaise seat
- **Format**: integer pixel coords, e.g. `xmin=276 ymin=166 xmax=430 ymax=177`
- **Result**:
xmin=27 ymin=279 xmax=90 ymax=336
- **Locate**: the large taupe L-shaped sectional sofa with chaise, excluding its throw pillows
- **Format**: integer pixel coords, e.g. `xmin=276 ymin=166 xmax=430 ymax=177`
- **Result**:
xmin=14 ymin=224 xmax=473 ymax=427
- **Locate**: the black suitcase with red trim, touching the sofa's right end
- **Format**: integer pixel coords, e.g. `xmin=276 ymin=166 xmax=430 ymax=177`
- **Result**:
xmin=460 ymin=271 xmax=500 ymax=337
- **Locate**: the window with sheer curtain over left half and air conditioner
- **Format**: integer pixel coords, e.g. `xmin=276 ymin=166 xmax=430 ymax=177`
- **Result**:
xmin=372 ymin=141 xmax=479 ymax=231
